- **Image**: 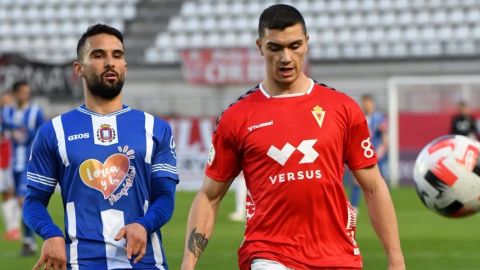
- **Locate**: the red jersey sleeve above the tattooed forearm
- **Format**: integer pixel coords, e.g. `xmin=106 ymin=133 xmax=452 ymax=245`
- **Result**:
xmin=205 ymin=117 xmax=241 ymax=182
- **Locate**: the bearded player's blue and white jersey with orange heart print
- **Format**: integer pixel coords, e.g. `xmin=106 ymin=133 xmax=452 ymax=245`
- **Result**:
xmin=27 ymin=106 xmax=178 ymax=270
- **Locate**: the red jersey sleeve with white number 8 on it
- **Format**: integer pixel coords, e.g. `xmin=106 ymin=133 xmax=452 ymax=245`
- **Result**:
xmin=346 ymin=101 xmax=378 ymax=170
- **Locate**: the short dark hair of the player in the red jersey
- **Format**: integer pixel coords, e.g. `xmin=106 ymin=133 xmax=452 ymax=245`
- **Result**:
xmin=258 ymin=4 xmax=307 ymax=38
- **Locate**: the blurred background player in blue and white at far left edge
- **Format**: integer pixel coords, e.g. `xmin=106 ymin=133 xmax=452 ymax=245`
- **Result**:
xmin=2 ymin=81 xmax=44 ymax=256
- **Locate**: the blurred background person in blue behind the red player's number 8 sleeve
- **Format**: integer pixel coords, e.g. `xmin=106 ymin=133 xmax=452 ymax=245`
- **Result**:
xmin=350 ymin=94 xmax=388 ymax=213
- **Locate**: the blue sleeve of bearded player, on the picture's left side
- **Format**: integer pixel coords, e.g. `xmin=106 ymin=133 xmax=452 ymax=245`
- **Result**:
xmin=27 ymin=122 xmax=60 ymax=192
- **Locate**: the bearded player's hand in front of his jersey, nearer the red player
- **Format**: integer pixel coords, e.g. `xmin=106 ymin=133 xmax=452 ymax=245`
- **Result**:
xmin=115 ymin=223 xmax=147 ymax=263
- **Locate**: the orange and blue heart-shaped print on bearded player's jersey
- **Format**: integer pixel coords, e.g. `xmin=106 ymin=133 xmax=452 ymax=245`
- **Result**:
xmin=78 ymin=146 xmax=136 ymax=205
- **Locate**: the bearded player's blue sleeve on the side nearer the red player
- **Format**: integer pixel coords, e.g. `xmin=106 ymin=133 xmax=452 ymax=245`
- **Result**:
xmin=151 ymin=118 xmax=179 ymax=181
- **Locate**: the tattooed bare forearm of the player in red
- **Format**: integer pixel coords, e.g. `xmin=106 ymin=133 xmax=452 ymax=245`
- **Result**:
xmin=181 ymin=176 xmax=233 ymax=270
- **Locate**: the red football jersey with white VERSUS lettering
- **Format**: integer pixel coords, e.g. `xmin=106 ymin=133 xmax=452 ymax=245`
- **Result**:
xmin=206 ymin=81 xmax=377 ymax=270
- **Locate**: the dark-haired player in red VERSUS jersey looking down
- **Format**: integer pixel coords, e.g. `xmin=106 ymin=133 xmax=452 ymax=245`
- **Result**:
xmin=182 ymin=5 xmax=405 ymax=270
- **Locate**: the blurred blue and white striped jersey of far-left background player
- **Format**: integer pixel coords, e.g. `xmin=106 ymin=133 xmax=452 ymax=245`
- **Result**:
xmin=2 ymin=104 xmax=44 ymax=172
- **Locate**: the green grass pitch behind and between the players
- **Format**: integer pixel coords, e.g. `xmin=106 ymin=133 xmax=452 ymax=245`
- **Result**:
xmin=0 ymin=187 xmax=480 ymax=270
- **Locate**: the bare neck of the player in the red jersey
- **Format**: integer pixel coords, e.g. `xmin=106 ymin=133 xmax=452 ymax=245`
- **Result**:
xmin=262 ymin=73 xmax=311 ymax=96
